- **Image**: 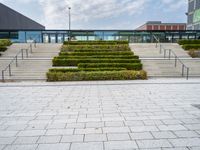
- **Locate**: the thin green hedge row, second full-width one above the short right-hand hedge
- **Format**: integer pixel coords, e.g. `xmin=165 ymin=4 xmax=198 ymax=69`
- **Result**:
xmin=54 ymin=55 xmax=139 ymax=59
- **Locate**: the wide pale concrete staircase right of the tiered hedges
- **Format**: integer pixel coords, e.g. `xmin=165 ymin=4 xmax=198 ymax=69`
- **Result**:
xmin=130 ymin=43 xmax=200 ymax=77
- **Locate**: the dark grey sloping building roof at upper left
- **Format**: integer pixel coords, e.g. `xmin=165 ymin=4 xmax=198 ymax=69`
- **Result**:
xmin=0 ymin=3 xmax=45 ymax=30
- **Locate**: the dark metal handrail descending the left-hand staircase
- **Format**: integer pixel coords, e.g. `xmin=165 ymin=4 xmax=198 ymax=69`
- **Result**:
xmin=1 ymin=43 xmax=33 ymax=82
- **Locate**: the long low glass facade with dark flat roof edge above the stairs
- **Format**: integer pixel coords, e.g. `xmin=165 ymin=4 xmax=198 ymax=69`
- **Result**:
xmin=0 ymin=30 xmax=200 ymax=43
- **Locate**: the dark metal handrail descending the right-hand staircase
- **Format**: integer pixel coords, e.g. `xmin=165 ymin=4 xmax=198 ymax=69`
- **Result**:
xmin=153 ymin=35 xmax=190 ymax=80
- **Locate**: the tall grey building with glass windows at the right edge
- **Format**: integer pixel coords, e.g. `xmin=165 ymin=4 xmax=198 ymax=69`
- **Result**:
xmin=186 ymin=0 xmax=200 ymax=30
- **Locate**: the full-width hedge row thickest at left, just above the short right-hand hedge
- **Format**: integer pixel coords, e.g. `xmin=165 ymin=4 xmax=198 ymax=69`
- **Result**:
xmin=52 ymin=58 xmax=141 ymax=66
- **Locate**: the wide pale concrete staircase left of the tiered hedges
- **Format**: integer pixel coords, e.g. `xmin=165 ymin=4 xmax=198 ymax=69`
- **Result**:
xmin=0 ymin=44 xmax=61 ymax=81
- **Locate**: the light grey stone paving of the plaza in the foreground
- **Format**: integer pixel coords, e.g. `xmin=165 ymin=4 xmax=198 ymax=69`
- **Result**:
xmin=0 ymin=81 xmax=200 ymax=150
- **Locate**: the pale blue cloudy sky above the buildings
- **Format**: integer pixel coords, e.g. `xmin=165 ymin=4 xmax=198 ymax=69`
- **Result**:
xmin=0 ymin=0 xmax=188 ymax=29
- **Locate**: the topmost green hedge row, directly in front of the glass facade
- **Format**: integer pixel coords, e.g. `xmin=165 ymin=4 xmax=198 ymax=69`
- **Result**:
xmin=63 ymin=41 xmax=129 ymax=45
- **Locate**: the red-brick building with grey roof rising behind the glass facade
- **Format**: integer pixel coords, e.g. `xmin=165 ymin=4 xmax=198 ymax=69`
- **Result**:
xmin=136 ymin=21 xmax=186 ymax=31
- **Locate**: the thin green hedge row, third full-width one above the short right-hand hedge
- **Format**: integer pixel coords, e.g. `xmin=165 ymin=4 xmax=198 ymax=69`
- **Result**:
xmin=59 ymin=52 xmax=134 ymax=56
